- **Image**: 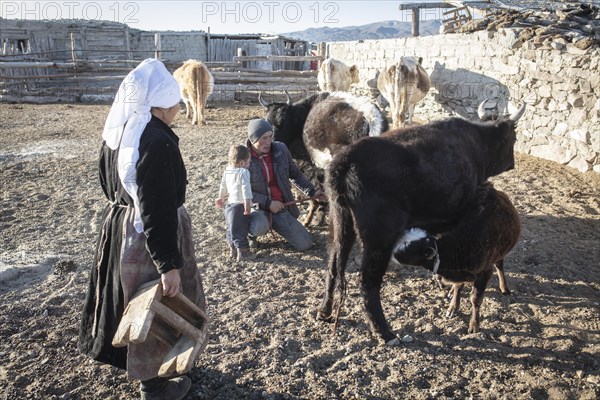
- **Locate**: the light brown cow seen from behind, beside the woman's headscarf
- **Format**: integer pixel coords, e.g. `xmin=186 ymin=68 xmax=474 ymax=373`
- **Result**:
xmin=173 ymin=60 xmax=214 ymax=125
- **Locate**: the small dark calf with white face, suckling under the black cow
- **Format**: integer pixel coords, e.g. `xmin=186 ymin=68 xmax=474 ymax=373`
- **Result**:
xmin=393 ymin=183 xmax=521 ymax=333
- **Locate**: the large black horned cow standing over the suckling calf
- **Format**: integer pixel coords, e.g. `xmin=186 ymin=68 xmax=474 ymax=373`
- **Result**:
xmin=317 ymin=106 xmax=525 ymax=344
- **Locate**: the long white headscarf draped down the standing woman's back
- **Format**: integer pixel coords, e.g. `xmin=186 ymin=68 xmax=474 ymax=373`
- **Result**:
xmin=102 ymin=58 xmax=181 ymax=232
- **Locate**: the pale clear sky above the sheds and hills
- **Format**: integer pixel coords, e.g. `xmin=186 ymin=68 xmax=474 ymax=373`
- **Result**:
xmin=0 ymin=0 xmax=440 ymax=34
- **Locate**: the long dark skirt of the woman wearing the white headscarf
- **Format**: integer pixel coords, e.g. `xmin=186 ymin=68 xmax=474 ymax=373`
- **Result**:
xmin=78 ymin=206 xmax=206 ymax=380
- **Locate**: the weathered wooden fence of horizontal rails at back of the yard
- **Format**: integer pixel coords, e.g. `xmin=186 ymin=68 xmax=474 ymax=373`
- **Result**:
xmin=0 ymin=54 xmax=323 ymax=103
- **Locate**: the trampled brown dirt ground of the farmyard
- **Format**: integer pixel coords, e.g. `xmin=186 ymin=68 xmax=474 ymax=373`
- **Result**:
xmin=0 ymin=103 xmax=600 ymax=400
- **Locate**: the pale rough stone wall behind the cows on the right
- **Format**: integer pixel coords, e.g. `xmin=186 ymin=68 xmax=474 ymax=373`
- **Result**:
xmin=327 ymin=29 xmax=600 ymax=172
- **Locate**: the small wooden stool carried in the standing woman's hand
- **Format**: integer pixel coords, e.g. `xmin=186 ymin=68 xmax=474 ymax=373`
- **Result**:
xmin=112 ymin=280 xmax=209 ymax=376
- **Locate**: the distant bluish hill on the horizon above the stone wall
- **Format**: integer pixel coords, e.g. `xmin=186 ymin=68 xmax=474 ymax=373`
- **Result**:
xmin=281 ymin=20 xmax=441 ymax=43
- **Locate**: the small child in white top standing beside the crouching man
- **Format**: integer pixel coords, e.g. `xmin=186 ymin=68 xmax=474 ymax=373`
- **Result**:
xmin=215 ymin=145 xmax=252 ymax=261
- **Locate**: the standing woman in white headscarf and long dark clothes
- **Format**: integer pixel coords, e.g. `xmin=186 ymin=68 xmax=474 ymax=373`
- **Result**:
xmin=79 ymin=59 xmax=206 ymax=400
